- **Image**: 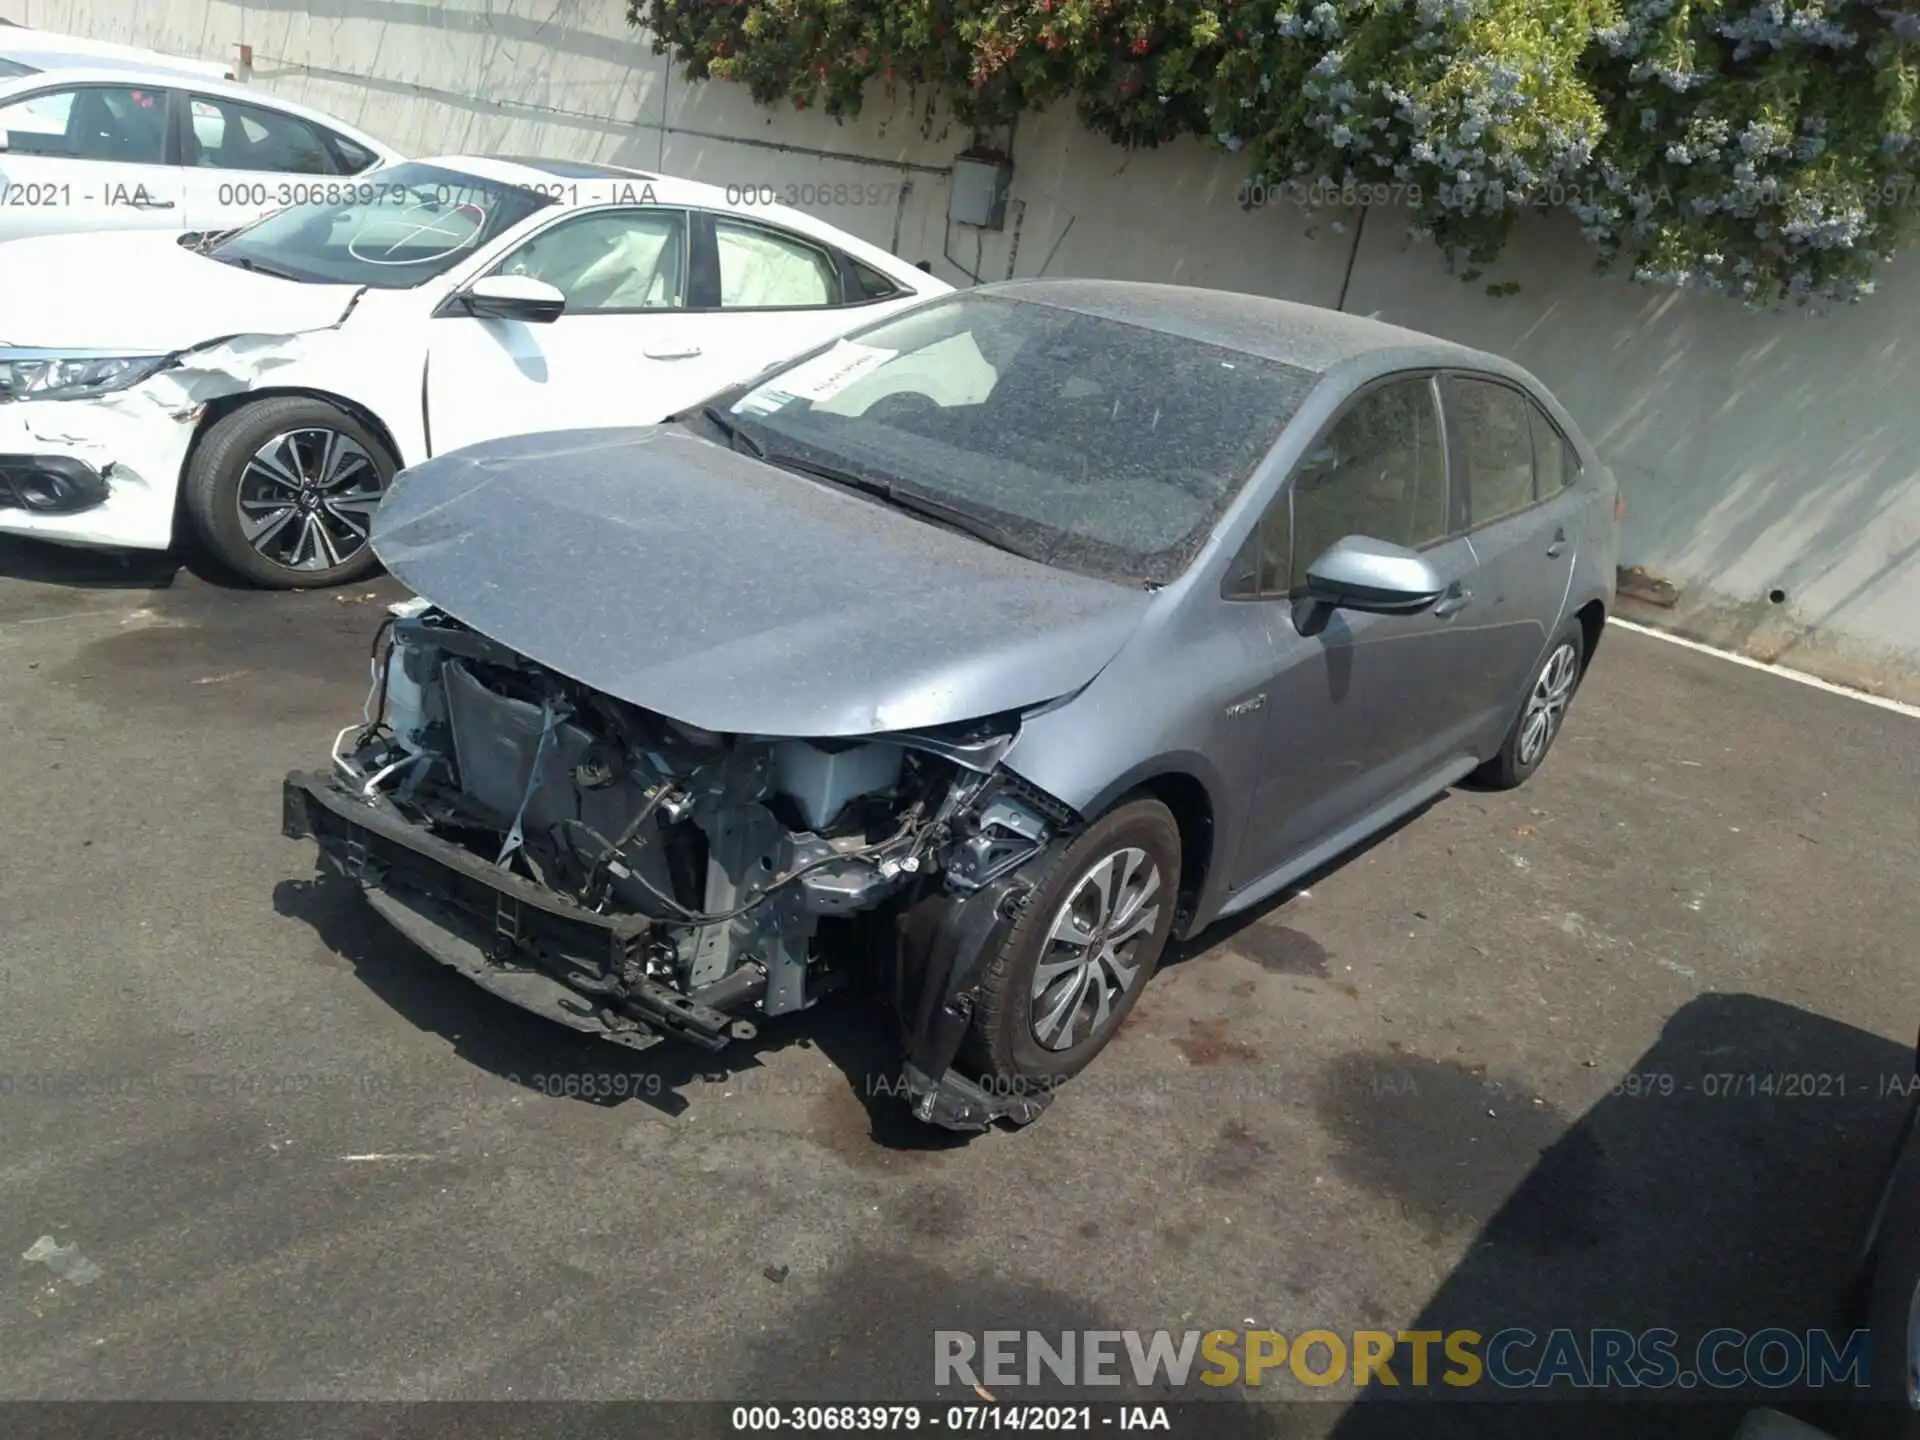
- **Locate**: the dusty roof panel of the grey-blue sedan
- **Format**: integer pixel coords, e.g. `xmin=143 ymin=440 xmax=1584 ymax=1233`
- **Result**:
xmin=979 ymin=280 xmax=1505 ymax=374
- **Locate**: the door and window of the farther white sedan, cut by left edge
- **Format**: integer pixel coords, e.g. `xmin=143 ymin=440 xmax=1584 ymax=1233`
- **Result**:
xmin=0 ymin=77 xmax=182 ymax=240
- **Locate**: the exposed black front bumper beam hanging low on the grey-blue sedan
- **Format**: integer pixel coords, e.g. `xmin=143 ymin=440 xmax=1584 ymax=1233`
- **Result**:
xmin=280 ymin=772 xmax=755 ymax=1050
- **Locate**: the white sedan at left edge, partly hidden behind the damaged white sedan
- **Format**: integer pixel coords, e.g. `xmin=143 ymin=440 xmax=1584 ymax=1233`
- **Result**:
xmin=0 ymin=64 xmax=401 ymax=240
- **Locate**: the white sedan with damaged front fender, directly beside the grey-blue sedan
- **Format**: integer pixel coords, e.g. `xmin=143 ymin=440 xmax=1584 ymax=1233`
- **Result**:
xmin=0 ymin=157 xmax=950 ymax=588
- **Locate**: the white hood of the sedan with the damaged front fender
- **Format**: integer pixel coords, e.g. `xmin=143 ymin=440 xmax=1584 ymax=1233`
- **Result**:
xmin=0 ymin=230 xmax=359 ymax=353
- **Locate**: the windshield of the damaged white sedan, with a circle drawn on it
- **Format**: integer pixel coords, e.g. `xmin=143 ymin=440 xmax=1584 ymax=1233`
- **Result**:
xmin=207 ymin=161 xmax=551 ymax=290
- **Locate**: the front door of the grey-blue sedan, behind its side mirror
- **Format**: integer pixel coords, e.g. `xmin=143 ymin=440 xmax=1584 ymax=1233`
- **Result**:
xmin=1235 ymin=374 xmax=1475 ymax=887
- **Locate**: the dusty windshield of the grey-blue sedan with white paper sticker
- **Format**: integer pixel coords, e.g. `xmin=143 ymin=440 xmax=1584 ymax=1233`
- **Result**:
xmin=722 ymin=294 xmax=1319 ymax=584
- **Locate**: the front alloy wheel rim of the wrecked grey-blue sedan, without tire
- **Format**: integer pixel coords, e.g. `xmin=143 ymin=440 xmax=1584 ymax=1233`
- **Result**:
xmin=1031 ymin=847 xmax=1162 ymax=1050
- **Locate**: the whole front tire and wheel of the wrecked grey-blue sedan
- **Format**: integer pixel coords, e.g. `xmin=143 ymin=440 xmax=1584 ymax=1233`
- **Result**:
xmin=968 ymin=799 xmax=1181 ymax=1092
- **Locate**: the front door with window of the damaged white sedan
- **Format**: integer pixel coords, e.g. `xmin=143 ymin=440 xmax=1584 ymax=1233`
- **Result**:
xmin=426 ymin=207 xmax=732 ymax=453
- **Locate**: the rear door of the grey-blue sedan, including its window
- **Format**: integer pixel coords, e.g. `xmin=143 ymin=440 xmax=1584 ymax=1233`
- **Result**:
xmin=1440 ymin=372 xmax=1582 ymax=732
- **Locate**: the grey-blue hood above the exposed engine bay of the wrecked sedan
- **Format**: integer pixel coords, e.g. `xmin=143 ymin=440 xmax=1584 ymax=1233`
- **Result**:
xmin=372 ymin=426 xmax=1150 ymax=737
